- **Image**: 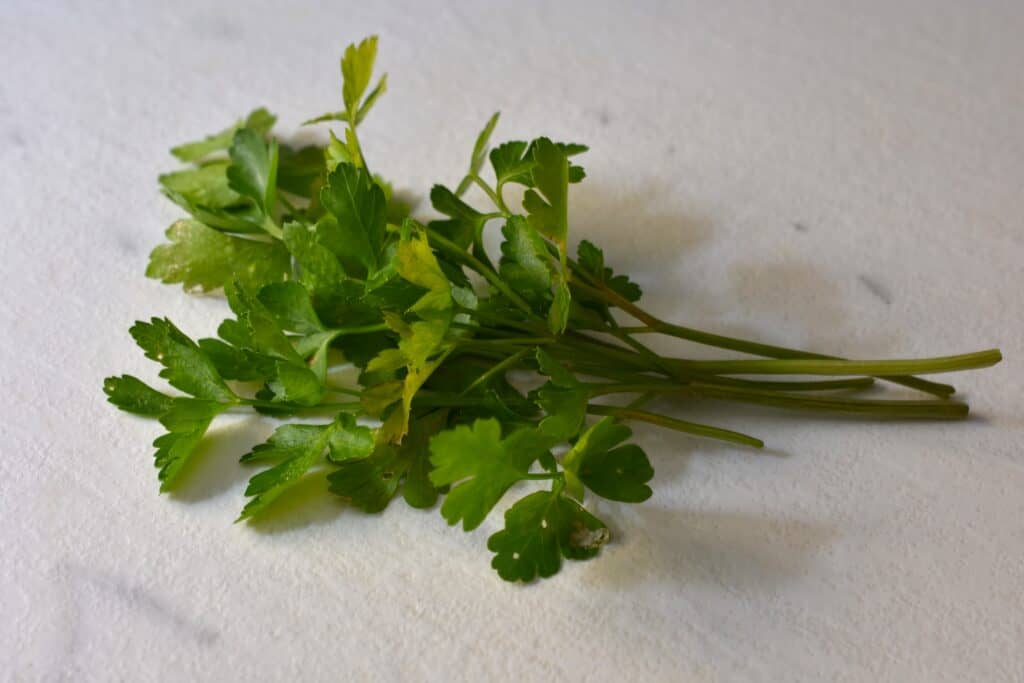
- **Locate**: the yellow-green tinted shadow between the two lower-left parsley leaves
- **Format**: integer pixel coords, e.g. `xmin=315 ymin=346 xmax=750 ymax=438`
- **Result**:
xmin=171 ymin=415 xmax=273 ymax=503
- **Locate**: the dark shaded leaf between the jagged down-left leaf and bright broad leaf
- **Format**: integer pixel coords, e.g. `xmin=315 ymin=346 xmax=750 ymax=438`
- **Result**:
xmin=328 ymin=411 xmax=446 ymax=512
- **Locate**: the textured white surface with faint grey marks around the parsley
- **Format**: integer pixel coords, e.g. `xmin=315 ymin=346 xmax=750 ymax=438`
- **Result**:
xmin=0 ymin=0 xmax=1024 ymax=681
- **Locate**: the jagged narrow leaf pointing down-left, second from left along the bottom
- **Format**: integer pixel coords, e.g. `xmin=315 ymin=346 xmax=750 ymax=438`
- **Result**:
xmin=238 ymin=414 xmax=365 ymax=521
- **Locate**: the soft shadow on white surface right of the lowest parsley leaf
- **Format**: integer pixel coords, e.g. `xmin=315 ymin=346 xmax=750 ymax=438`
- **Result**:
xmin=587 ymin=504 xmax=836 ymax=590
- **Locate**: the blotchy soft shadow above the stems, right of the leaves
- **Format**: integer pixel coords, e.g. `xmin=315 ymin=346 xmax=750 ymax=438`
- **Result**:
xmin=569 ymin=178 xmax=903 ymax=357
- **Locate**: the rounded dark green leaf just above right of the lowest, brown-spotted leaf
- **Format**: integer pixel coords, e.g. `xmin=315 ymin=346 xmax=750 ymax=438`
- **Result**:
xmin=562 ymin=417 xmax=654 ymax=503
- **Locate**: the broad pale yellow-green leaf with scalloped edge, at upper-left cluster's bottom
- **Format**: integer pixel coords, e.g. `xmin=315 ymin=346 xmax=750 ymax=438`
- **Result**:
xmin=145 ymin=219 xmax=292 ymax=292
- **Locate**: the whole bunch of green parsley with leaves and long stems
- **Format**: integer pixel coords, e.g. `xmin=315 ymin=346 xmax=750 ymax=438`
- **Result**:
xmin=103 ymin=38 xmax=999 ymax=581
